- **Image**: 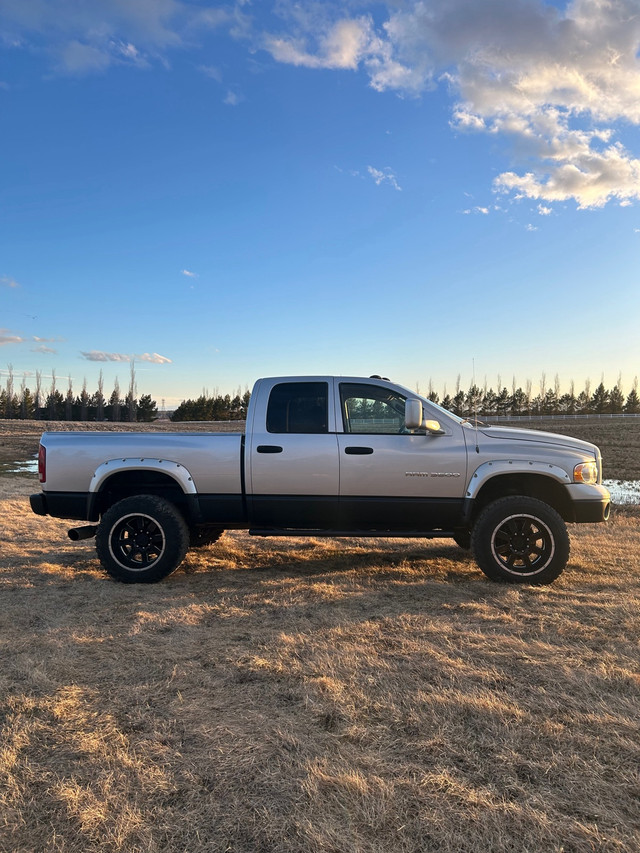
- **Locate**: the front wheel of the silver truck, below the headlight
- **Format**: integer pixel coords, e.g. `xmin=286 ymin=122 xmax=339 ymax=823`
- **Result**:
xmin=471 ymin=496 xmax=569 ymax=584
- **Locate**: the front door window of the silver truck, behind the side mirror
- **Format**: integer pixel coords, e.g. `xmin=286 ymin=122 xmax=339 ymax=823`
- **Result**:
xmin=340 ymin=382 xmax=406 ymax=435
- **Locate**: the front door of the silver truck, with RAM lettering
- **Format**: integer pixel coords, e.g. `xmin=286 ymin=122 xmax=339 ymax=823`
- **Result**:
xmin=336 ymin=382 xmax=467 ymax=531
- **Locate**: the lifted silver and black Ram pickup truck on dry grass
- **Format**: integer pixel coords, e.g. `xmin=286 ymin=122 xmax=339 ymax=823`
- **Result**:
xmin=31 ymin=376 xmax=610 ymax=584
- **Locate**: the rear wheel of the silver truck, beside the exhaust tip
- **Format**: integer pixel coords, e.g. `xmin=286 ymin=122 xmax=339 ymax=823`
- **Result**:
xmin=96 ymin=495 xmax=189 ymax=583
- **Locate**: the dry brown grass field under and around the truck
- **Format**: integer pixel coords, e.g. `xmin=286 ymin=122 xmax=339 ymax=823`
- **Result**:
xmin=0 ymin=422 xmax=640 ymax=853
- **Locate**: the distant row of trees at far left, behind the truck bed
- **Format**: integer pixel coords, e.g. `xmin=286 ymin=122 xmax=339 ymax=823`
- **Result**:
xmin=0 ymin=363 xmax=158 ymax=422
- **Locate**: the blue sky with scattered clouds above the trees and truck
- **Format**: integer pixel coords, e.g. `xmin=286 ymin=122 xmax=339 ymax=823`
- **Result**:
xmin=0 ymin=0 xmax=640 ymax=406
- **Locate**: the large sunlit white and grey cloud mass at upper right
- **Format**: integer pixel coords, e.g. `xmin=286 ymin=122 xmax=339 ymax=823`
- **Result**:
xmin=265 ymin=0 xmax=640 ymax=208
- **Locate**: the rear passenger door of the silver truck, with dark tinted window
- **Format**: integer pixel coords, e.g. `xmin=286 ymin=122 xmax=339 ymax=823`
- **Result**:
xmin=247 ymin=380 xmax=339 ymax=530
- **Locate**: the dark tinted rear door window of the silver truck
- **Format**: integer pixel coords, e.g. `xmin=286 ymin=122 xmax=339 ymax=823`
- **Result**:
xmin=267 ymin=382 xmax=329 ymax=433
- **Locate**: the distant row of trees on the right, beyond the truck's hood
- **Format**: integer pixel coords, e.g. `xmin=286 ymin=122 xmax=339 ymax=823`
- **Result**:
xmin=427 ymin=373 xmax=640 ymax=418
